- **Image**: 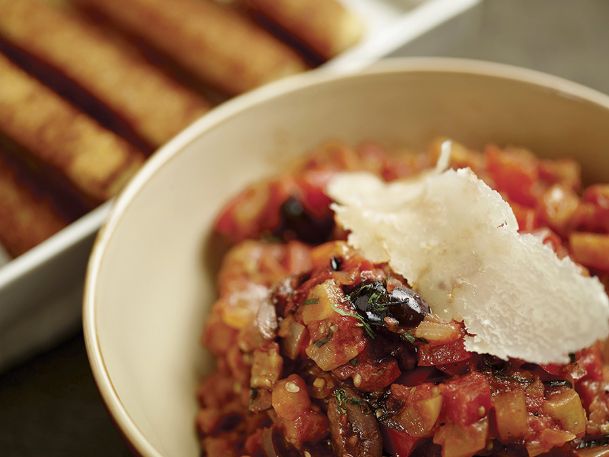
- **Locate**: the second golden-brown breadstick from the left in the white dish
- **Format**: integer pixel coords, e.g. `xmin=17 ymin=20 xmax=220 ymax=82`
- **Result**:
xmin=0 ymin=52 xmax=143 ymax=206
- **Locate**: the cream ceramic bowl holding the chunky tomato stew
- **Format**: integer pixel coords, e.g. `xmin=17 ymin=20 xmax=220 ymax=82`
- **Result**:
xmin=84 ymin=59 xmax=609 ymax=457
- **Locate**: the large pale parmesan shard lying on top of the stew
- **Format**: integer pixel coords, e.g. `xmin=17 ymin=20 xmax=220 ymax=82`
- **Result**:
xmin=328 ymin=169 xmax=609 ymax=363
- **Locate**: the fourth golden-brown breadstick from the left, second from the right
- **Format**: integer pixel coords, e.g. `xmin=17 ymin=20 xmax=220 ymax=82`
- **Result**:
xmin=78 ymin=0 xmax=306 ymax=94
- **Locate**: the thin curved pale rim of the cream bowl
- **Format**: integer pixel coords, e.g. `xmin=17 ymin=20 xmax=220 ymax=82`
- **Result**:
xmin=83 ymin=57 xmax=609 ymax=457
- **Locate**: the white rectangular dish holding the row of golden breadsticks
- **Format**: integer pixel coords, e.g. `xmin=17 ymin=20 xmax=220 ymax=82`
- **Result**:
xmin=0 ymin=0 xmax=481 ymax=370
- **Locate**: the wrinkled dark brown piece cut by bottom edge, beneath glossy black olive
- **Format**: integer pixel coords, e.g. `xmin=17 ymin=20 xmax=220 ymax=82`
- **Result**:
xmin=328 ymin=389 xmax=383 ymax=457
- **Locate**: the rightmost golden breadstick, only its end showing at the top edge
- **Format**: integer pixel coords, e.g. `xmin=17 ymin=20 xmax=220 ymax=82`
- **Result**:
xmin=246 ymin=0 xmax=363 ymax=59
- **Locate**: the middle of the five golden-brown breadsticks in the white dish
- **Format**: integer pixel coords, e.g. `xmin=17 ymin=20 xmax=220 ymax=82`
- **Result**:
xmin=0 ymin=0 xmax=209 ymax=151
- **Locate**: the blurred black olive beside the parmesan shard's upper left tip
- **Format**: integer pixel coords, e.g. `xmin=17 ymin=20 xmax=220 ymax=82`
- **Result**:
xmin=273 ymin=196 xmax=334 ymax=244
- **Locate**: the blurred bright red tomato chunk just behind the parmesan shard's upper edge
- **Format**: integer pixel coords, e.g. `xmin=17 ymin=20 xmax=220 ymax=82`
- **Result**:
xmin=485 ymin=146 xmax=539 ymax=208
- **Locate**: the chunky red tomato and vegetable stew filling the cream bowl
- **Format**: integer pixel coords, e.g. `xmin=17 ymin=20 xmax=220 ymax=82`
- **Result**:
xmin=196 ymin=142 xmax=609 ymax=457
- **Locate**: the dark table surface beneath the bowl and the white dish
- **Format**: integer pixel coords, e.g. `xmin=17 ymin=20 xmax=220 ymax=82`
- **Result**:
xmin=0 ymin=0 xmax=609 ymax=457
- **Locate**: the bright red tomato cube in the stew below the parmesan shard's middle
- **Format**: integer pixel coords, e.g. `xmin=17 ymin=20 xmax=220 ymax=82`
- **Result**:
xmin=441 ymin=372 xmax=491 ymax=425
